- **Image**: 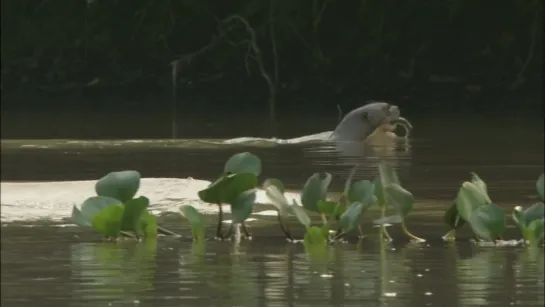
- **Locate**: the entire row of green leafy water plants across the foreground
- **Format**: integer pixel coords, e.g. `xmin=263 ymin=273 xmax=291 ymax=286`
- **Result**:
xmin=72 ymin=152 xmax=545 ymax=254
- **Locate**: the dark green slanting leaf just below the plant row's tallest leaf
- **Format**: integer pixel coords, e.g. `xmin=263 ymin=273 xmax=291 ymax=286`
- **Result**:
xmin=198 ymin=173 xmax=257 ymax=205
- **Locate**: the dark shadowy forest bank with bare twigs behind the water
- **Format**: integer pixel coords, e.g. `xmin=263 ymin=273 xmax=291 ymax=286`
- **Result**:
xmin=1 ymin=0 xmax=544 ymax=118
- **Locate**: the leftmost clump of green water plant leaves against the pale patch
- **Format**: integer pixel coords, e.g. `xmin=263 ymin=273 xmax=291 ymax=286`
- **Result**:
xmin=72 ymin=170 xmax=173 ymax=239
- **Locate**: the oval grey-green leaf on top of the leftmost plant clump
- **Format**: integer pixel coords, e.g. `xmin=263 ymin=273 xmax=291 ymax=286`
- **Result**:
xmin=95 ymin=171 xmax=140 ymax=203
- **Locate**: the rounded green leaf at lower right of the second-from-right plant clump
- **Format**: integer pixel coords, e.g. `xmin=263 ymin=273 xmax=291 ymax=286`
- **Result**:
xmin=468 ymin=204 xmax=505 ymax=241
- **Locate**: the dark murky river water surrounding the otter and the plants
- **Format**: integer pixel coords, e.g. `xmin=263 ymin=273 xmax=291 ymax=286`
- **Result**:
xmin=1 ymin=118 xmax=544 ymax=307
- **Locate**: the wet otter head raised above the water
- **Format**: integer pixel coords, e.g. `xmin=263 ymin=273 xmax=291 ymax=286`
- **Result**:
xmin=331 ymin=102 xmax=410 ymax=142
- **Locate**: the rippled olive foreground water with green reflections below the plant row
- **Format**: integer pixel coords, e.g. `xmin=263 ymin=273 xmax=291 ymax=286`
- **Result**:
xmin=1 ymin=227 xmax=544 ymax=307
